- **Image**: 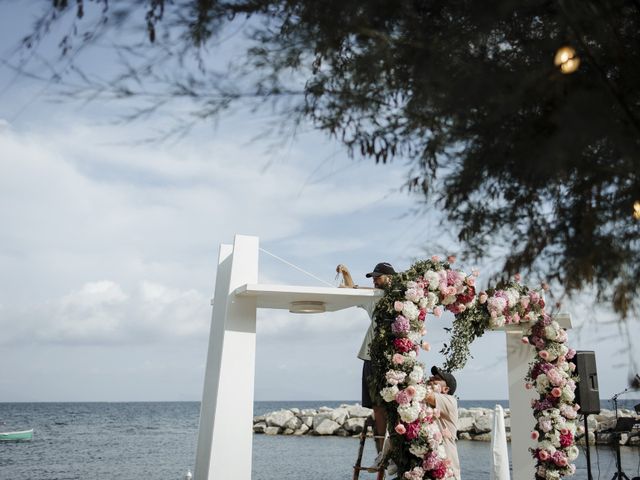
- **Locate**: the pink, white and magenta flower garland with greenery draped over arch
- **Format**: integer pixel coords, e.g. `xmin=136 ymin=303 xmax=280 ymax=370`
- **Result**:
xmin=364 ymin=257 xmax=579 ymax=480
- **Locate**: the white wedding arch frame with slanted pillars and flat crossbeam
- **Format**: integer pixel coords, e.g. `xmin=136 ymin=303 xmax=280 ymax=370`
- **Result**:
xmin=195 ymin=235 xmax=571 ymax=480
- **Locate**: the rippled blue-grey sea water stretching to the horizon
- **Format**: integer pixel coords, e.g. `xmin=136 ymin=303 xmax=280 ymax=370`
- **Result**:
xmin=0 ymin=400 xmax=640 ymax=480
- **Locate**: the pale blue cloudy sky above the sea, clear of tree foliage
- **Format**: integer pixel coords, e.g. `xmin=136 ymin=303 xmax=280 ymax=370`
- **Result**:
xmin=0 ymin=1 xmax=639 ymax=402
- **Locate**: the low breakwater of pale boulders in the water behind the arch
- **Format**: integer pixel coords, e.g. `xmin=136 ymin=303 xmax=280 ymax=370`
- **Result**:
xmin=253 ymin=404 xmax=640 ymax=446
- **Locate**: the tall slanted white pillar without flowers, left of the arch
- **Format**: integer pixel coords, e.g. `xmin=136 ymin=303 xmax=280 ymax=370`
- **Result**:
xmin=195 ymin=235 xmax=258 ymax=480
